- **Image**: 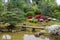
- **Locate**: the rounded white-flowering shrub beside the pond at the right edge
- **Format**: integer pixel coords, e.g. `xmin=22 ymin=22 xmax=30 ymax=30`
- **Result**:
xmin=48 ymin=25 xmax=60 ymax=35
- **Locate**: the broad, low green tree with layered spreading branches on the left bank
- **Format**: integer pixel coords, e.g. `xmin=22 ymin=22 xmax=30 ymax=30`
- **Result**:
xmin=1 ymin=11 xmax=24 ymax=25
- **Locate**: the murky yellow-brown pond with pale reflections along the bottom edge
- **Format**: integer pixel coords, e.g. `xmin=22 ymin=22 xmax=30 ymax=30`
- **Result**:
xmin=0 ymin=31 xmax=60 ymax=40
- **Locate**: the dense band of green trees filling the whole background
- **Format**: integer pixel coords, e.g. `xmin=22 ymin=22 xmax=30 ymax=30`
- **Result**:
xmin=0 ymin=0 xmax=60 ymax=24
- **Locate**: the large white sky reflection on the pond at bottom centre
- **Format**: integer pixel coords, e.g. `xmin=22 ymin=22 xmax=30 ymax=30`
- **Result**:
xmin=24 ymin=34 xmax=50 ymax=40
